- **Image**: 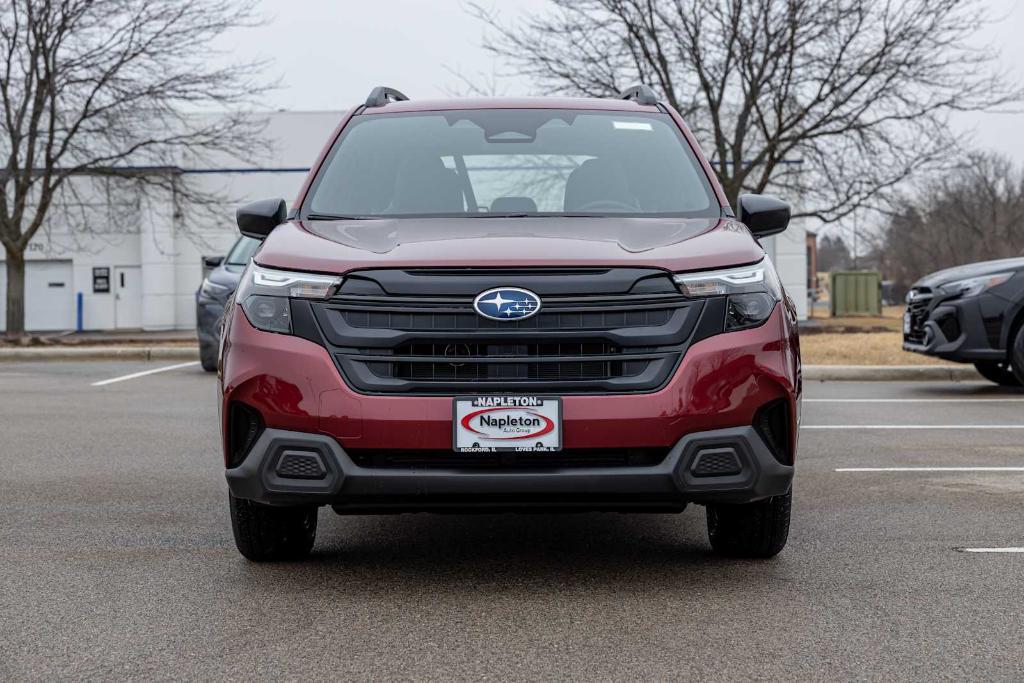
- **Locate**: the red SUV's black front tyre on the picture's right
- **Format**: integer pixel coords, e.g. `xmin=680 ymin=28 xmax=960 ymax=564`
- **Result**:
xmin=708 ymin=493 xmax=793 ymax=557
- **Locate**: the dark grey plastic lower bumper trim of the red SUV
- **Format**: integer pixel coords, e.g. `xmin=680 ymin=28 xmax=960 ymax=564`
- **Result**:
xmin=227 ymin=427 xmax=794 ymax=513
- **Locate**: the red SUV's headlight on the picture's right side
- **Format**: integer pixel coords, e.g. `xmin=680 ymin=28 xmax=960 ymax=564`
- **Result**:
xmin=673 ymin=257 xmax=782 ymax=332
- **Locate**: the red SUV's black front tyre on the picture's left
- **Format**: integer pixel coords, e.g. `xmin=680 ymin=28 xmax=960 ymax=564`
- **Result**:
xmin=228 ymin=494 xmax=316 ymax=562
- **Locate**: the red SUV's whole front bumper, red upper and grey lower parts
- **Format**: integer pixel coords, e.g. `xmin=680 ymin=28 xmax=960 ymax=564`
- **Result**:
xmin=220 ymin=305 xmax=800 ymax=512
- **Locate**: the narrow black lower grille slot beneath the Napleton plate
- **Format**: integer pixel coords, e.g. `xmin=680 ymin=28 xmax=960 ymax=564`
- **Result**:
xmin=345 ymin=447 xmax=669 ymax=470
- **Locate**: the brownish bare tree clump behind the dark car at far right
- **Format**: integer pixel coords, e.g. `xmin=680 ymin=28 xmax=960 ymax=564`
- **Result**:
xmin=871 ymin=154 xmax=1024 ymax=291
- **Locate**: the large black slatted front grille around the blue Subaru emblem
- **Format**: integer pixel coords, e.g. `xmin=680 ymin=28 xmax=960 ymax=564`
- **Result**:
xmin=303 ymin=268 xmax=703 ymax=394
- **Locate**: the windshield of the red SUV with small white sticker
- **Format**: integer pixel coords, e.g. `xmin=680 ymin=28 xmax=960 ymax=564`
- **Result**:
xmin=302 ymin=110 xmax=720 ymax=219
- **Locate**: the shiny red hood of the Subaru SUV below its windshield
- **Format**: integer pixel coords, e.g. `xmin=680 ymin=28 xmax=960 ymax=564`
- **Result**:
xmin=249 ymin=217 xmax=764 ymax=273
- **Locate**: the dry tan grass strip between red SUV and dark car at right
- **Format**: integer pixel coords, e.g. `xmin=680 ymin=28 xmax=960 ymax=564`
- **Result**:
xmin=800 ymin=332 xmax=945 ymax=366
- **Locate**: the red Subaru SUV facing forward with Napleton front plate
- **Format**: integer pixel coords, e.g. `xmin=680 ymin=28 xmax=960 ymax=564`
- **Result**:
xmin=220 ymin=86 xmax=801 ymax=560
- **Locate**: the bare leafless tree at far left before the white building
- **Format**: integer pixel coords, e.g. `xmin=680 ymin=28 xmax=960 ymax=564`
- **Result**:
xmin=0 ymin=0 xmax=265 ymax=337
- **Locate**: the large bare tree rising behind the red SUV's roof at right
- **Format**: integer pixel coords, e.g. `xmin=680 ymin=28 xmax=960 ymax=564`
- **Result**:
xmin=471 ymin=0 xmax=1022 ymax=222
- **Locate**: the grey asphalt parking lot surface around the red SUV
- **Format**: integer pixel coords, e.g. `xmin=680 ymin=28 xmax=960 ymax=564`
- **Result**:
xmin=0 ymin=362 xmax=1024 ymax=680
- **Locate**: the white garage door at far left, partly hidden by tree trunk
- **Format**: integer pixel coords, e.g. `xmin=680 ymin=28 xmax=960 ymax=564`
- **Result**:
xmin=0 ymin=261 xmax=75 ymax=332
